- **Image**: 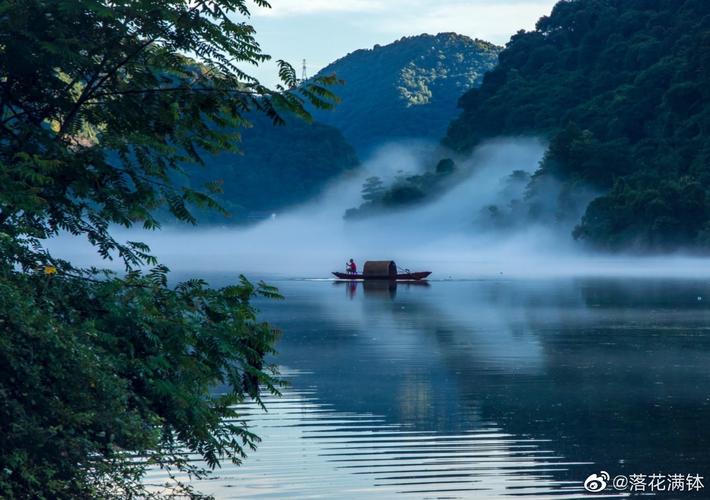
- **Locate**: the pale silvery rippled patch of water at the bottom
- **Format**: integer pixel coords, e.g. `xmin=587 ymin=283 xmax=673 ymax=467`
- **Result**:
xmin=147 ymin=390 xmax=628 ymax=499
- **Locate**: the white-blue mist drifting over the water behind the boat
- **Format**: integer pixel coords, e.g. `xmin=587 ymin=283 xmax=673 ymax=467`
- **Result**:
xmin=49 ymin=138 xmax=710 ymax=279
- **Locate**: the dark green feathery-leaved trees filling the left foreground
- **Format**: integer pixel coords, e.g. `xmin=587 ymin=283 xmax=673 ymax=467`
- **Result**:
xmin=0 ymin=0 xmax=335 ymax=498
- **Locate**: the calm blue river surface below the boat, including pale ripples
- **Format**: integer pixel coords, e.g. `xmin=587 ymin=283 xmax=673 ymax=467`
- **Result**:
xmin=146 ymin=279 xmax=710 ymax=498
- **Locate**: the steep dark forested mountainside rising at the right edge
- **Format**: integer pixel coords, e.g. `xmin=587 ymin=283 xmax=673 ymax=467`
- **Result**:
xmin=444 ymin=0 xmax=710 ymax=249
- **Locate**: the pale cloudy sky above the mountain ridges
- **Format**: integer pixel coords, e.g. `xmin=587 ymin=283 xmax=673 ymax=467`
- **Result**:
xmin=245 ymin=0 xmax=557 ymax=84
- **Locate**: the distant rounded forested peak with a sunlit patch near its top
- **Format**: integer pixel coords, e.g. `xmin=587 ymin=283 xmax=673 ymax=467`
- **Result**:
xmin=314 ymin=33 xmax=500 ymax=158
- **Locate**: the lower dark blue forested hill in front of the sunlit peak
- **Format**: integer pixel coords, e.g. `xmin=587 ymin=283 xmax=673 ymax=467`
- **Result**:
xmin=188 ymin=114 xmax=358 ymax=223
